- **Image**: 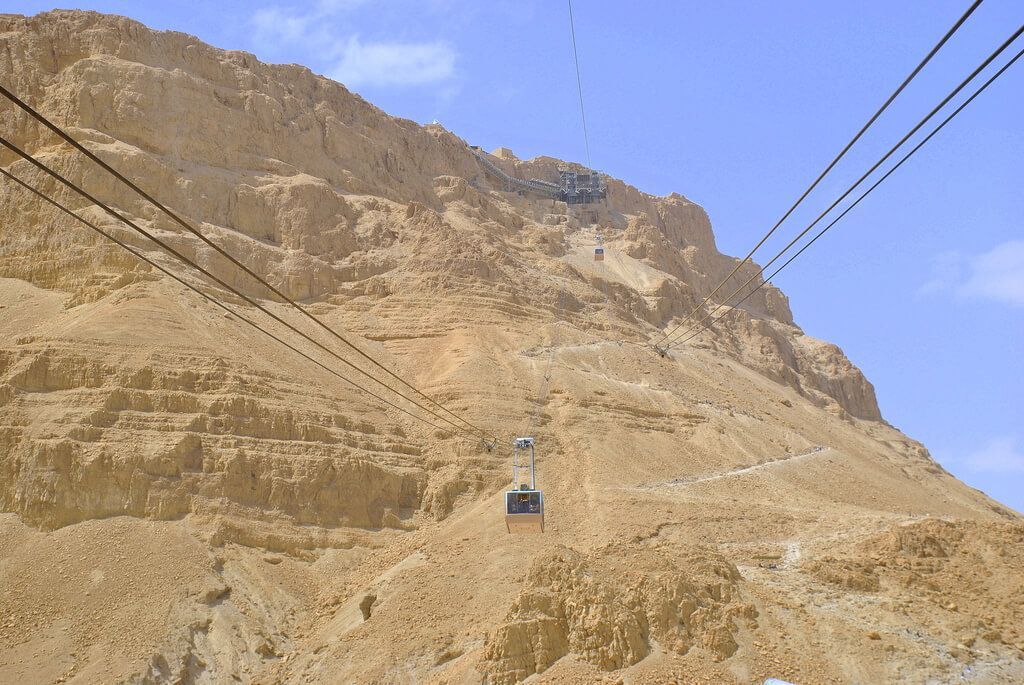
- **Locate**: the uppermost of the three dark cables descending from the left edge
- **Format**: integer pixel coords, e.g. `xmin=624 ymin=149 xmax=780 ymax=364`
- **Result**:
xmin=0 ymin=85 xmax=487 ymax=443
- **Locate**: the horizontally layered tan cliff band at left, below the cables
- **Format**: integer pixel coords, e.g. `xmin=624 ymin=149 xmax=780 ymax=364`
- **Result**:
xmin=0 ymin=345 xmax=425 ymax=527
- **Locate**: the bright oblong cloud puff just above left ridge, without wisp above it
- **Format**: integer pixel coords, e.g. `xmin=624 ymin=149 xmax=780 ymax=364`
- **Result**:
xmin=330 ymin=36 xmax=456 ymax=87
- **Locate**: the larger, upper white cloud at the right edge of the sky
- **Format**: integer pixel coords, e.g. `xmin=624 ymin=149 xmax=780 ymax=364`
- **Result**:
xmin=919 ymin=241 xmax=1024 ymax=307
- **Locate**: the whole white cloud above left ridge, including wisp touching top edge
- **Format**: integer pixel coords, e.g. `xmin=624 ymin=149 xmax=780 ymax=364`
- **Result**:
xmin=251 ymin=0 xmax=458 ymax=87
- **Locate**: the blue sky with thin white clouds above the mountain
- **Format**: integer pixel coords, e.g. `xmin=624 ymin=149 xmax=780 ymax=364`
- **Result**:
xmin=4 ymin=0 xmax=1024 ymax=511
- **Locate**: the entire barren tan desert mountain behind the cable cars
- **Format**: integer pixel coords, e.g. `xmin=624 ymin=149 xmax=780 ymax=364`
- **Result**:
xmin=0 ymin=11 xmax=1024 ymax=684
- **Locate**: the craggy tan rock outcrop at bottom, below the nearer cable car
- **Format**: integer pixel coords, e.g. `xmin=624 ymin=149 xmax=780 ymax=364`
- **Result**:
xmin=483 ymin=548 xmax=757 ymax=685
